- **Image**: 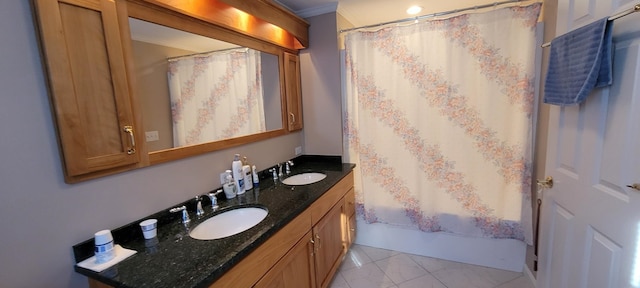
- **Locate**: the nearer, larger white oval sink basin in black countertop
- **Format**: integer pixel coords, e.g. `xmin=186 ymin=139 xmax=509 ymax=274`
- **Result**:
xmin=189 ymin=207 xmax=268 ymax=240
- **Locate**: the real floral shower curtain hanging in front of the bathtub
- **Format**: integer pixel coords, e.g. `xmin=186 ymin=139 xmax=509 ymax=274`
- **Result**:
xmin=343 ymin=3 xmax=541 ymax=244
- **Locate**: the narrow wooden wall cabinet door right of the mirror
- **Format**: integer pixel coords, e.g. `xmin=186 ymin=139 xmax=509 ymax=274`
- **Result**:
xmin=284 ymin=53 xmax=302 ymax=131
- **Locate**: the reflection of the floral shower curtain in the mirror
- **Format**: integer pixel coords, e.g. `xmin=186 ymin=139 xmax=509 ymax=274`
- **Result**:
xmin=168 ymin=48 xmax=266 ymax=147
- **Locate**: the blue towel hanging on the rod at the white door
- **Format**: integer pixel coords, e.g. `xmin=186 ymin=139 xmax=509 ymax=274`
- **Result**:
xmin=544 ymin=18 xmax=613 ymax=106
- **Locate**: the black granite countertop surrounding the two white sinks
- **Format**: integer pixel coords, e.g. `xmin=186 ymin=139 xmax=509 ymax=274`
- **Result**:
xmin=73 ymin=155 xmax=355 ymax=288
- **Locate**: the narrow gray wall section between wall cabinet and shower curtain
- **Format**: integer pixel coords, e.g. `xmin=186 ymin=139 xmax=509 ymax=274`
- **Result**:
xmin=300 ymin=12 xmax=342 ymax=155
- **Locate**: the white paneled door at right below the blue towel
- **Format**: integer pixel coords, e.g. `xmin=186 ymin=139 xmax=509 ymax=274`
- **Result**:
xmin=537 ymin=1 xmax=640 ymax=288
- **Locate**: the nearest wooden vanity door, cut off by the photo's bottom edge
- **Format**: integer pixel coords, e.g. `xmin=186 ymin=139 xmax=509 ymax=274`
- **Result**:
xmin=253 ymin=232 xmax=316 ymax=288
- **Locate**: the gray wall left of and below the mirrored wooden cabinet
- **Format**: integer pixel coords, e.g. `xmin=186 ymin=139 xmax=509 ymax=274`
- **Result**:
xmin=0 ymin=0 xmax=302 ymax=288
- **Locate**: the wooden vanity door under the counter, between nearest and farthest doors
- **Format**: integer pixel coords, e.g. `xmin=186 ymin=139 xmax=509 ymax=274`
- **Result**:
xmin=313 ymin=201 xmax=346 ymax=288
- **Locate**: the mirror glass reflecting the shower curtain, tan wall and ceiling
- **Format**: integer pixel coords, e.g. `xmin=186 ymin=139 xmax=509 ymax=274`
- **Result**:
xmin=129 ymin=18 xmax=283 ymax=152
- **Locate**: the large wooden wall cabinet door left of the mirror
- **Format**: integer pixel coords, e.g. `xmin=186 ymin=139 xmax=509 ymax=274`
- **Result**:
xmin=34 ymin=0 xmax=140 ymax=182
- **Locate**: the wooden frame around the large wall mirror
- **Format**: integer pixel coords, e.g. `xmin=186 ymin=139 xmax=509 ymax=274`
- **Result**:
xmin=125 ymin=1 xmax=290 ymax=165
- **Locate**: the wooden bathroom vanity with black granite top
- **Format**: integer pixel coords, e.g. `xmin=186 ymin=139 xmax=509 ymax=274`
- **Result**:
xmin=74 ymin=156 xmax=356 ymax=288
